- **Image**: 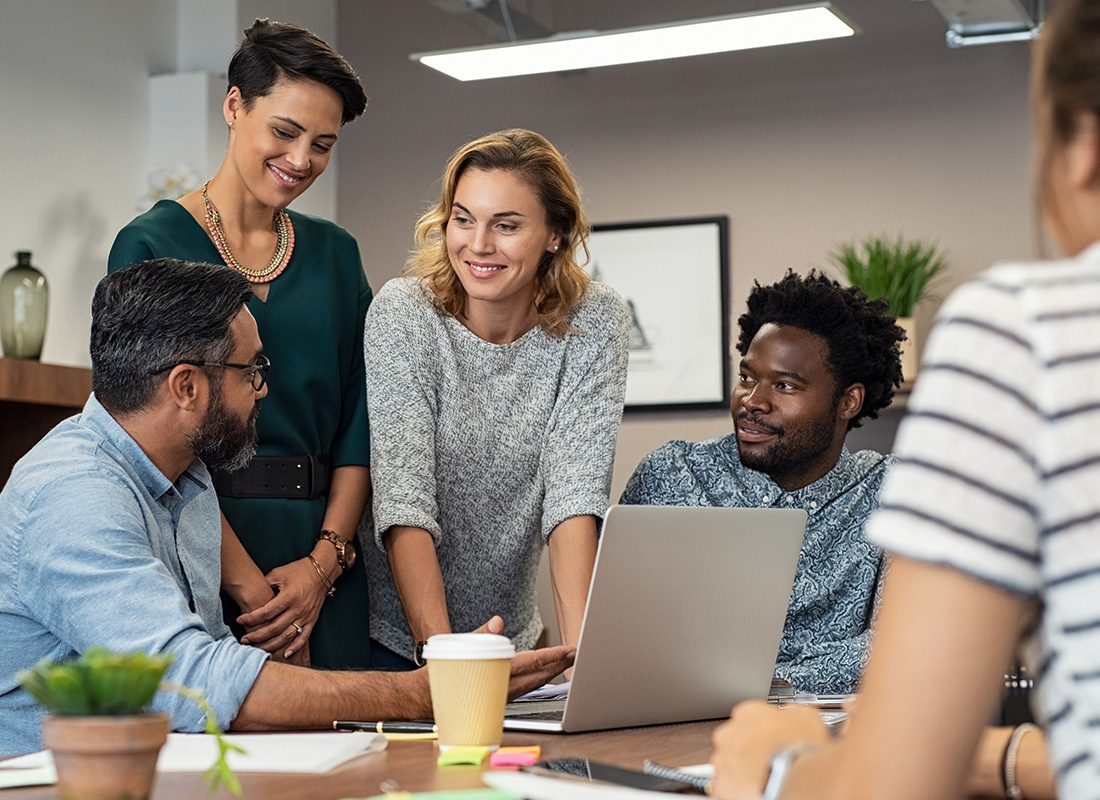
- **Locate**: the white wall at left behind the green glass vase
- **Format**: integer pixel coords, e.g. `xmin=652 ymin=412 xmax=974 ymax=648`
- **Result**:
xmin=0 ymin=0 xmax=175 ymax=364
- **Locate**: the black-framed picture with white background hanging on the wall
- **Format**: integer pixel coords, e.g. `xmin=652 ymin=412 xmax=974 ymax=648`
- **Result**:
xmin=587 ymin=217 xmax=729 ymax=410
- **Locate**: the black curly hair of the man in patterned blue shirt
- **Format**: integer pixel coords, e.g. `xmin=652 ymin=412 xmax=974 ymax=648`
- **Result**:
xmin=737 ymin=270 xmax=905 ymax=430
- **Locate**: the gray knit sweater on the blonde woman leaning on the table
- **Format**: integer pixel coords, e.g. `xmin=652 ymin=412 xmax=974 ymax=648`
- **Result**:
xmin=362 ymin=277 xmax=629 ymax=658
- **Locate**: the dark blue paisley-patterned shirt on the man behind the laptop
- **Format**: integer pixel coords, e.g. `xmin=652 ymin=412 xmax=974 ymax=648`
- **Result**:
xmin=620 ymin=434 xmax=893 ymax=693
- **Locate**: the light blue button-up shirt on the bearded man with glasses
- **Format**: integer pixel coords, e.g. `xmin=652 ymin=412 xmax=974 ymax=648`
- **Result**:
xmin=0 ymin=395 xmax=267 ymax=756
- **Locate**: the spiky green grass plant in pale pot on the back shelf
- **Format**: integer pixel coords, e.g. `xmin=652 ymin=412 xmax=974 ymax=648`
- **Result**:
xmin=828 ymin=235 xmax=947 ymax=381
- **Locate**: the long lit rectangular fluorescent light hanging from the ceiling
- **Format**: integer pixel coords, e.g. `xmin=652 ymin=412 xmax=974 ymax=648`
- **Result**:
xmin=409 ymin=2 xmax=856 ymax=80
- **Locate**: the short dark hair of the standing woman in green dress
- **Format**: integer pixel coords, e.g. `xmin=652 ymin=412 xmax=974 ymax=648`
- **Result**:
xmin=227 ymin=19 xmax=366 ymax=124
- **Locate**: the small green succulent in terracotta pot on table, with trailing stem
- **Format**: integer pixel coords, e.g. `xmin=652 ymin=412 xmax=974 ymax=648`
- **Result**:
xmin=18 ymin=647 xmax=241 ymax=800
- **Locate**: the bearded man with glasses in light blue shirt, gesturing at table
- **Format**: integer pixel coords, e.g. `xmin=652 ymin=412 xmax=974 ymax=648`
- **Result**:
xmin=0 ymin=259 xmax=571 ymax=756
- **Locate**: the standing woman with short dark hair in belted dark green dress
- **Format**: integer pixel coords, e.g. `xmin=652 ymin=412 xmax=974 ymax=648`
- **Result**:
xmin=109 ymin=20 xmax=371 ymax=668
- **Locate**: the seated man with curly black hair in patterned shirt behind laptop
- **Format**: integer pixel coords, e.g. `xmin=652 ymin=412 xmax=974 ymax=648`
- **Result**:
xmin=622 ymin=272 xmax=904 ymax=693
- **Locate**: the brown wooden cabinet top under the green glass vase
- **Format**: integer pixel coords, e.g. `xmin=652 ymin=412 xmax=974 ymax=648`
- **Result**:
xmin=0 ymin=359 xmax=91 ymax=486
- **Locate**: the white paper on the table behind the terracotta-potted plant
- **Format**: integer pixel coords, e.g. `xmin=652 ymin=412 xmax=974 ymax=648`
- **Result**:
xmin=0 ymin=732 xmax=386 ymax=774
